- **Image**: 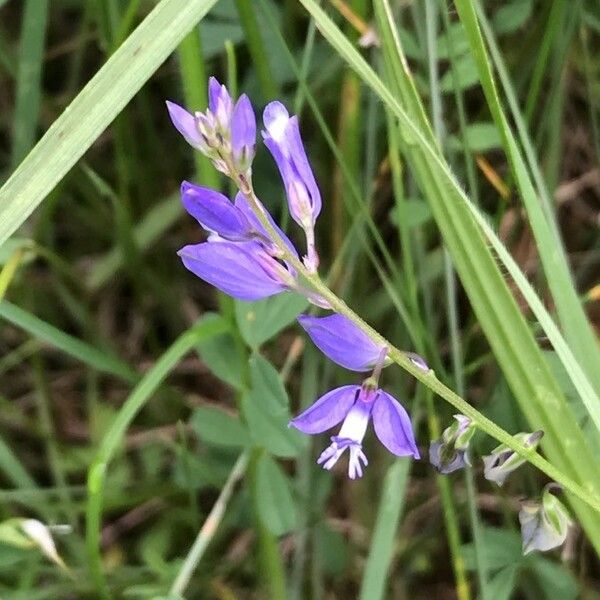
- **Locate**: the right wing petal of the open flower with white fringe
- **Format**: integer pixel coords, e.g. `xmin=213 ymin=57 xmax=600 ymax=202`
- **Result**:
xmin=372 ymin=390 xmax=419 ymax=458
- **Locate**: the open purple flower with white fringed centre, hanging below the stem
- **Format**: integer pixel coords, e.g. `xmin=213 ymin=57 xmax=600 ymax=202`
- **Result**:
xmin=290 ymin=378 xmax=419 ymax=479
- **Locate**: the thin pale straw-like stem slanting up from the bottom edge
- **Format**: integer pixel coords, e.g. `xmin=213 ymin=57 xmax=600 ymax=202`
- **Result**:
xmin=169 ymin=452 xmax=248 ymax=596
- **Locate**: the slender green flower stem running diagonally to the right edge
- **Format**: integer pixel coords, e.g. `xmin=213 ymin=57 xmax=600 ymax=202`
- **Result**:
xmin=232 ymin=171 xmax=600 ymax=513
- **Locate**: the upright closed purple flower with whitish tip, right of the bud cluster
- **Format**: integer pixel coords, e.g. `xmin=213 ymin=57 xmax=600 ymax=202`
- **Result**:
xmin=263 ymin=102 xmax=321 ymax=271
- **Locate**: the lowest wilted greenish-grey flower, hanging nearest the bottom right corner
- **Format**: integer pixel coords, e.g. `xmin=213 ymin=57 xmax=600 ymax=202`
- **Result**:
xmin=519 ymin=483 xmax=572 ymax=554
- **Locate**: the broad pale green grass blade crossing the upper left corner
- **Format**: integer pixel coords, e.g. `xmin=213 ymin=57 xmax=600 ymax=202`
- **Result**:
xmin=0 ymin=0 xmax=216 ymax=244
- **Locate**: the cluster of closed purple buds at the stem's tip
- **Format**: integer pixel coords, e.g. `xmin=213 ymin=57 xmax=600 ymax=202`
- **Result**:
xmin=167 ymin=77 xmax=256 ymax=176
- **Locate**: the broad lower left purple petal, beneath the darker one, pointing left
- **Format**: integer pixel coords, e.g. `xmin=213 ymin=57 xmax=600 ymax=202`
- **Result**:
xmin=178 ymin=242 xmax=286 ymax=300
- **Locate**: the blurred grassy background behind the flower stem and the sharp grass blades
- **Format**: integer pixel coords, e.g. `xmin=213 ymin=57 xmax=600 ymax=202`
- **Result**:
xmin=0 ymin=0 xmax=600 ymax=600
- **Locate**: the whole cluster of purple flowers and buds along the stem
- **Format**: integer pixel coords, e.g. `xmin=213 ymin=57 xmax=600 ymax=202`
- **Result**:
xmin=167 ymin=78 xmax=428 ymax=479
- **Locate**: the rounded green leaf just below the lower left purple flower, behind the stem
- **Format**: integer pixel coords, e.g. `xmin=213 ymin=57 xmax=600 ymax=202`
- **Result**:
xmin=235 ymin=292 xmax=308 ymax=348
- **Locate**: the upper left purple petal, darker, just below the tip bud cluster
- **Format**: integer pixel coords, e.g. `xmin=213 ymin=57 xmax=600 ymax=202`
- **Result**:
xmin=181 ymin=181 xmax=251 ymax=240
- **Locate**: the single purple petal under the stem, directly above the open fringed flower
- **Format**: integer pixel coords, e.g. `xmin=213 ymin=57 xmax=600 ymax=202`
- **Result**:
xmin=298 ymin=314 xmax=383 ymax=371
